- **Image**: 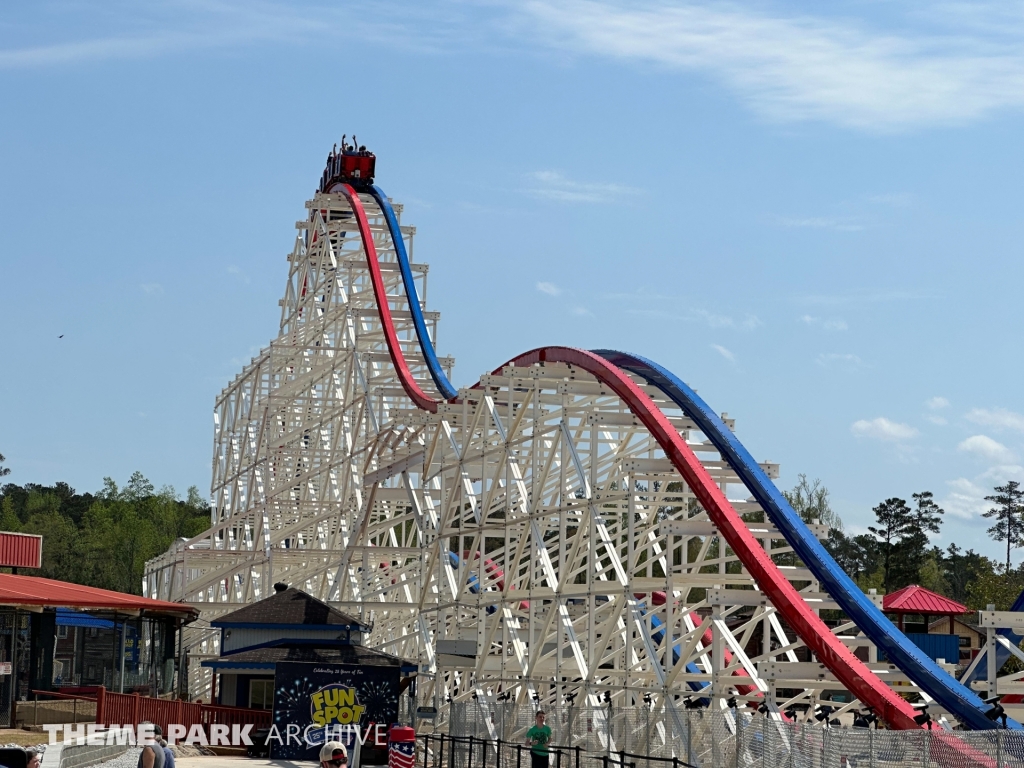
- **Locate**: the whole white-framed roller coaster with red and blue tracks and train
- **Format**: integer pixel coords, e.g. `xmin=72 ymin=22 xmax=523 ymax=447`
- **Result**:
xmin=145 ymin=141 xmax=1024 ymax=741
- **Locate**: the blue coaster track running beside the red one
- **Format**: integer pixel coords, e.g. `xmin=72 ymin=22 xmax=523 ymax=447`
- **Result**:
xmin=367 ymin=185 xmax=1011 ymax=730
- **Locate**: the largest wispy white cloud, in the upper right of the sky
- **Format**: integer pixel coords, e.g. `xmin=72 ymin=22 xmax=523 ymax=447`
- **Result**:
xmin=523 ymin=0 xmax=1024 ymax=131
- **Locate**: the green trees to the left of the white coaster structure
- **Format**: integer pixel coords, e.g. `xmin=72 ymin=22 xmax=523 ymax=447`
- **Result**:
xmin=0 ymin=468 xmax=210 ymax=595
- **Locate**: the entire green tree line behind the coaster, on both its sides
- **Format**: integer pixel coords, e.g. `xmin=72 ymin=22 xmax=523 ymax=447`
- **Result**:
xmin=6 ymin=444 xmax=1024 ymax=610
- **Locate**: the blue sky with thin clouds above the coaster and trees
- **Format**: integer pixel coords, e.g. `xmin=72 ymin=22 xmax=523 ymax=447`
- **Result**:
xmin=0 ymin=0 xmax=1024 ymax=558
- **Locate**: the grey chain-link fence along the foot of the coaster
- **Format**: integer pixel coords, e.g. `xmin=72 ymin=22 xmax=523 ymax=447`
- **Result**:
xmin=417 ymin=700 xmax=1024 ymax=768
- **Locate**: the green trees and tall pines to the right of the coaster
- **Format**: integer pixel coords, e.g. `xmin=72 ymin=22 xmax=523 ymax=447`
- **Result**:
xmin=783 ymin=475 xmax=1024 ymax=610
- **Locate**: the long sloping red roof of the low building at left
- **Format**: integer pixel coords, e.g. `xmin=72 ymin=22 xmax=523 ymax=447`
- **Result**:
xmin=0 ymin=573 xmax=199 ymax=618
